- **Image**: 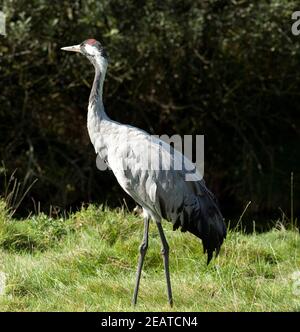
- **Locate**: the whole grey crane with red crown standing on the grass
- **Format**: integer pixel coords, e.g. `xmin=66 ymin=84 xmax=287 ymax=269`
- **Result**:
xmin=63 ymin=40 xmax=226 ymax=304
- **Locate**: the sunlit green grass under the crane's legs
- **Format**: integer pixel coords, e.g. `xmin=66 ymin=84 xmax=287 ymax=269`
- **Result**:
xmin=0 ymin=201 xmax=300 ymax=311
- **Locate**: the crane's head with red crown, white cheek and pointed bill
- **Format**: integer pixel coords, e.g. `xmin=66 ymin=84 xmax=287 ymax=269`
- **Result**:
xmin=61 ymin=39 xmax=108 ymax=64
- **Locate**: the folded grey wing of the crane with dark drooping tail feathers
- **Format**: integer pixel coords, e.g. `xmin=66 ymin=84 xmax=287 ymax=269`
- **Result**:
xmin=108 ymin=127 xmax=226 ymax=263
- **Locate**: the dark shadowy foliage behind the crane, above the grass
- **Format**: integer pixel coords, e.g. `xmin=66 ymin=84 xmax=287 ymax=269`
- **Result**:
xmin=0 ymin=0 xmax=300 ymax=223
